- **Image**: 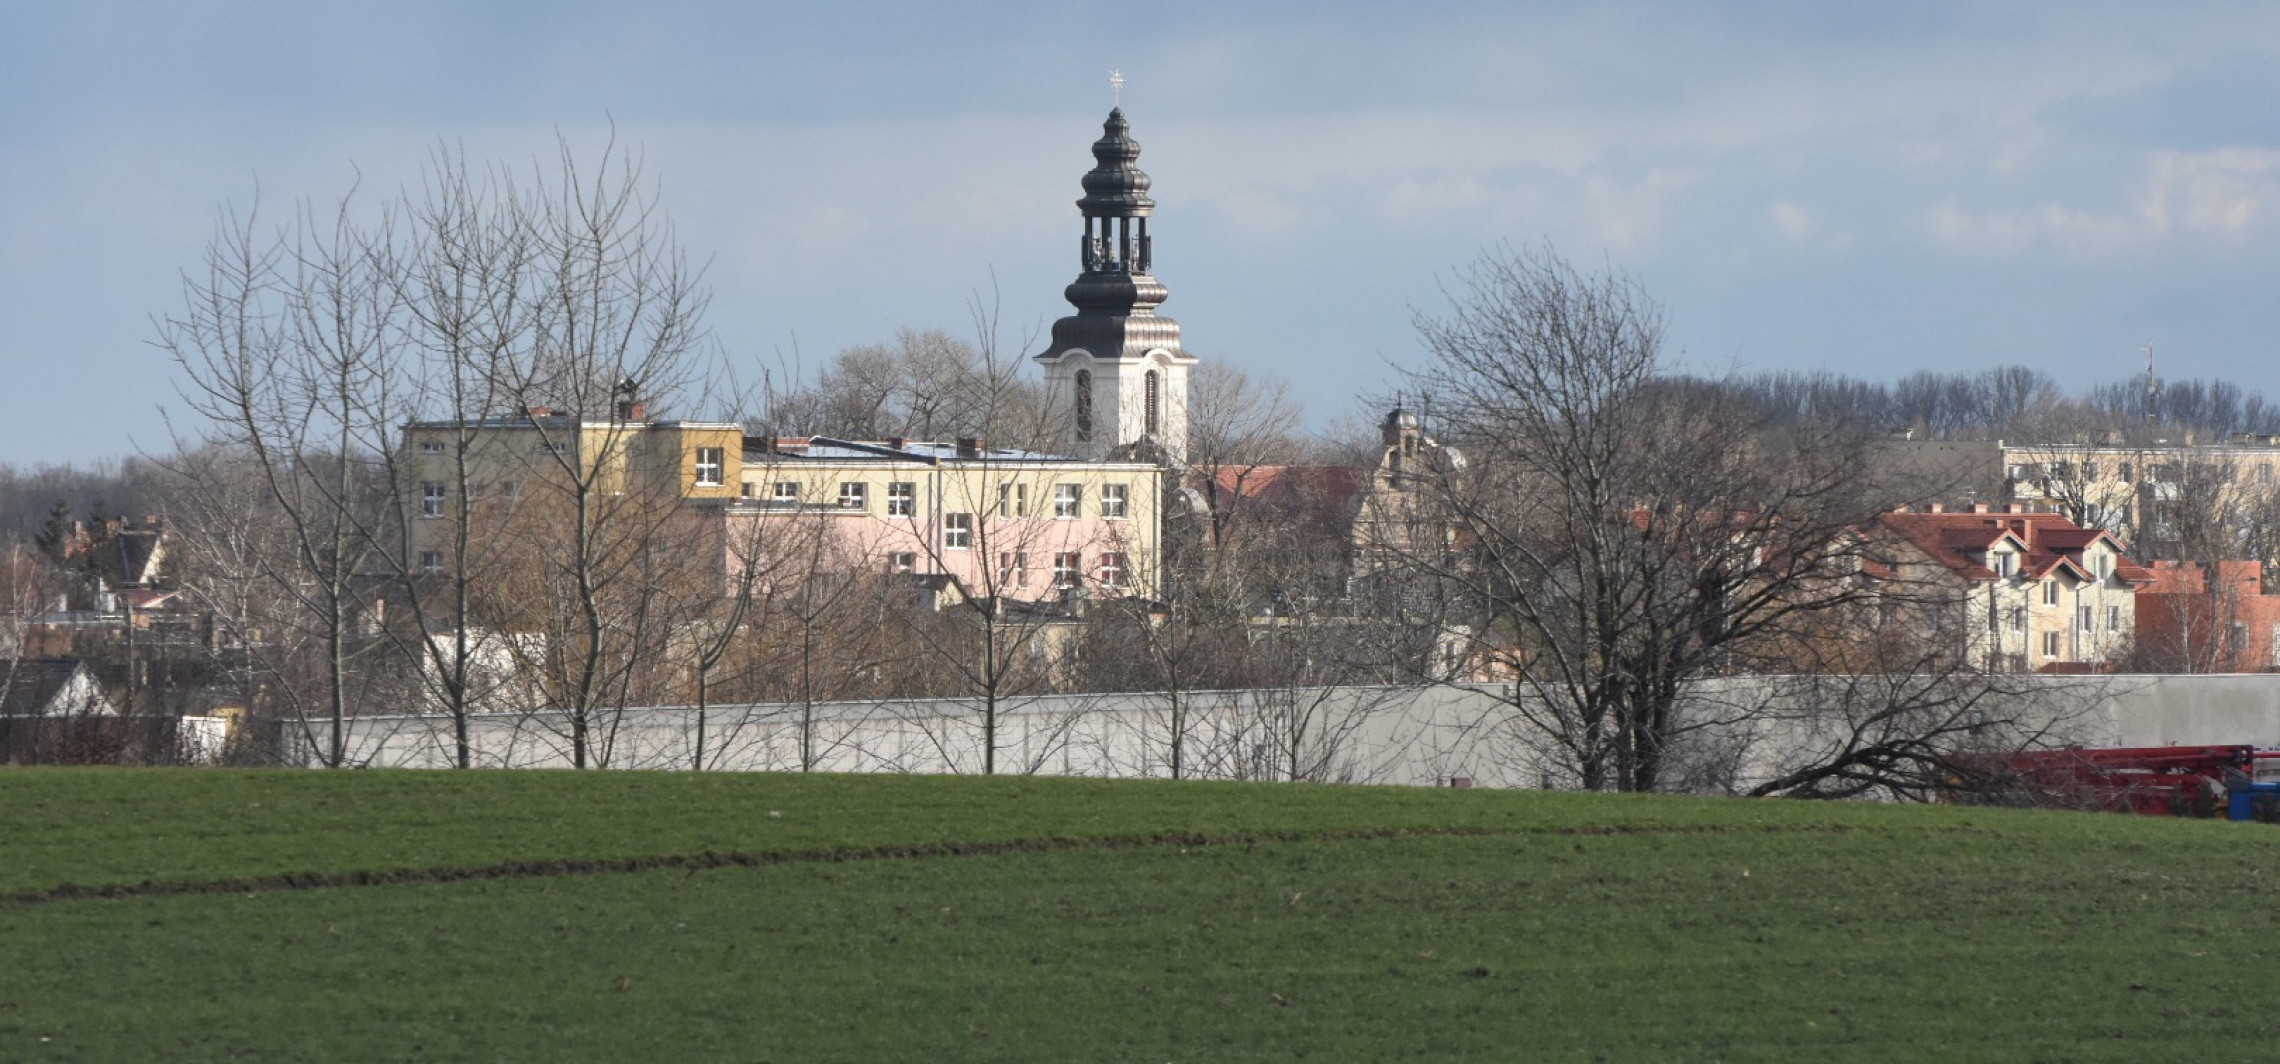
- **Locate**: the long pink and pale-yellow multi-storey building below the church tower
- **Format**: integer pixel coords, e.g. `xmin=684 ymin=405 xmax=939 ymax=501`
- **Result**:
xmin=720 ymin=437 xmax=1163 ymax=601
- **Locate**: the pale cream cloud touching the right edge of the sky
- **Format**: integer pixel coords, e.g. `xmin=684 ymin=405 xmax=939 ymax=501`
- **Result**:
xmin=1924 ymin=148 xmax=2280 ymax=255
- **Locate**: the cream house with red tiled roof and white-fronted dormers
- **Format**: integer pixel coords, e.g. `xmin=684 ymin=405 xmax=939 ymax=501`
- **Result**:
xmin=1876 ymin=504 xmax=2152 ymax=672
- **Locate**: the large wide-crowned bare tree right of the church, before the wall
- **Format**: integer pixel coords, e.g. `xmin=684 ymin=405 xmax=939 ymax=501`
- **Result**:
xmin=1407 ymin=251 xmax=1924 ymax=791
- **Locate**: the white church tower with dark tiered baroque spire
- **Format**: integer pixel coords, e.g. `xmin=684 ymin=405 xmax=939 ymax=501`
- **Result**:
xmin=1037 ymin=107 xmax=1195 ymax=465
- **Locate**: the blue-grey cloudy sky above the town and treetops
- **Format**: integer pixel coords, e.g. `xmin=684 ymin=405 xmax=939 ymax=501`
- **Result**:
xmin=0 ymin=0 xmax=2280 ymax=467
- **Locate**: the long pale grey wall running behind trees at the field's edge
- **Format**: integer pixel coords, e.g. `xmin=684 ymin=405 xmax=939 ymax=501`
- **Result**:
xmin=307 ymin=674 xmax=2280 ymax=788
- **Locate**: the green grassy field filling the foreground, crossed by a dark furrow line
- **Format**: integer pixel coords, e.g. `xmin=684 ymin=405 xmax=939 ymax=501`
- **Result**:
xmin=0 ymin=770 xmax=2280 ymax=1062
